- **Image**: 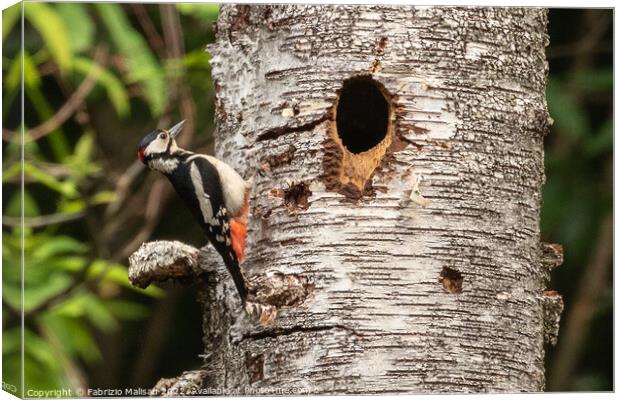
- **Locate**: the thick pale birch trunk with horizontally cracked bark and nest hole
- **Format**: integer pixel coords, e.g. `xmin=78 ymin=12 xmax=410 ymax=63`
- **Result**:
xmin=132 ymin=5 xmax=561 ymax=394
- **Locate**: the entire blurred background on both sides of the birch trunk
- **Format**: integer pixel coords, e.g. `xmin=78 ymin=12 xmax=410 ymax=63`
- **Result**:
xmin=2 ymin=2 xmax=613 ymax=391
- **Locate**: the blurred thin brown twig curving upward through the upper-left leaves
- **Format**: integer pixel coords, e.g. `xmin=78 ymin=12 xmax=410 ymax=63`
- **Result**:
xmin=2 ymin=48 xmax=106 ymax=143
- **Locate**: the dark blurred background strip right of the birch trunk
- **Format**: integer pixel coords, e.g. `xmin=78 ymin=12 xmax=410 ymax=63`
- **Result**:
xmin=541 ymin=9 xmax=614 ymax=391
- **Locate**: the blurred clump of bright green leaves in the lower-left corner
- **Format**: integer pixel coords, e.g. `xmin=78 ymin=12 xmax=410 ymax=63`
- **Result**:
xmin=2 ymin=208 xmax=162 ymax=389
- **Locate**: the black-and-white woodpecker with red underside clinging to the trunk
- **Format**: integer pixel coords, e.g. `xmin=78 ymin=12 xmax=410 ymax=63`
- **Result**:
xmin=138 ymin=120 xmax=251 ymax=304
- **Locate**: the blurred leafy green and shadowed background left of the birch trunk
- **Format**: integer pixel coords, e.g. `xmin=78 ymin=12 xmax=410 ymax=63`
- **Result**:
xmin=2 ymin=2 xmax=218 ymax=389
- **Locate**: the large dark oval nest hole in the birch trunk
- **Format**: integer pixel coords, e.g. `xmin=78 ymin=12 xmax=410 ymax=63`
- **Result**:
xmin=336 ymin=76 xmax=390 ymax=154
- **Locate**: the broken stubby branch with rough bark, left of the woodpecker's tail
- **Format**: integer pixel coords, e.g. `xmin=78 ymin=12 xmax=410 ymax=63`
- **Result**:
xmin=129 ymin=241 xmax=205 ymax=289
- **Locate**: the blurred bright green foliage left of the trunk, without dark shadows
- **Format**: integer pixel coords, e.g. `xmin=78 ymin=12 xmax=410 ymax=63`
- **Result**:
xmin=2 ymin=2 xmax=218 ymax=390
